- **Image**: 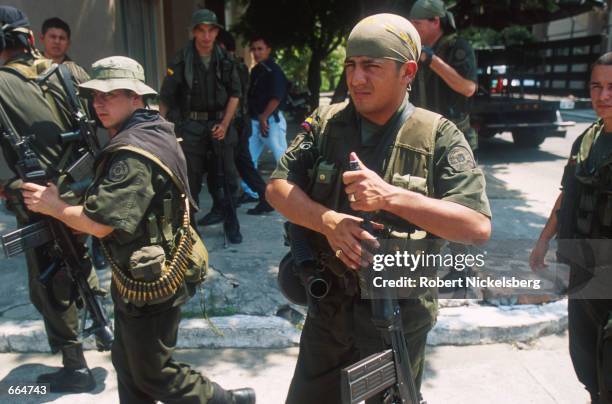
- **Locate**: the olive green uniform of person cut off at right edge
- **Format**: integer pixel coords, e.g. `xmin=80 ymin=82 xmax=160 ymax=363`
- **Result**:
xmin=559 ymin=120 xmax=612 ymax=403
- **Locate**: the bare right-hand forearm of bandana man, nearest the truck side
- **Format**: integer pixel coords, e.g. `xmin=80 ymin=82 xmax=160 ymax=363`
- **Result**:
xmin=384 ymin=187 xmax=491 ymax=244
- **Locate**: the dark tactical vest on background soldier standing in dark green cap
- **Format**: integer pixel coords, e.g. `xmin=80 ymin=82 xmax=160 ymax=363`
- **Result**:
xmin=179 ymin=42 xmax=234 ymax=119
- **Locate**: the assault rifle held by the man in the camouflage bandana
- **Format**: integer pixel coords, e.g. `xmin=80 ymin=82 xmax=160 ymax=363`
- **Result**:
xmin=341 ymin=156 xmax=419 ymax=404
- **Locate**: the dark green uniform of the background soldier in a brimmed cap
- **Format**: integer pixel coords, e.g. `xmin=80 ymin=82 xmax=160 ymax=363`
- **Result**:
xmin=160 ymin=41 xmax=241 ymax=215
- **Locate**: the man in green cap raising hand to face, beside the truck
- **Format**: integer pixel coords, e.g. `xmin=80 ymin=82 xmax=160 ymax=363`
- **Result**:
xmin=408 ymin=0 xmax=478 ymax=151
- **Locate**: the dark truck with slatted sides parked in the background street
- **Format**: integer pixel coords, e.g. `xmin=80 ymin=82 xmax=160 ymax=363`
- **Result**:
xmin=471 ymin=36 xmax=602 ymax=148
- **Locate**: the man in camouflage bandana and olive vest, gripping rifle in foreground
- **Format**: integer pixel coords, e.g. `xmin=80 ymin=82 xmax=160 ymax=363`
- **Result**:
xmin=266 ymin=14 xmax=491 ymax=404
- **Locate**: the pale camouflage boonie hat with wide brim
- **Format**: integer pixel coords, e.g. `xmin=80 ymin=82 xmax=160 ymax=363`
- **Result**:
xmin=79 ymin=56 xmax=157 ymax=95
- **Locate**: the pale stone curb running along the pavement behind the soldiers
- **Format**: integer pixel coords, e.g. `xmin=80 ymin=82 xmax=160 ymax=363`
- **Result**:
xmin=0 ymin=300 xmax=567 ymax=353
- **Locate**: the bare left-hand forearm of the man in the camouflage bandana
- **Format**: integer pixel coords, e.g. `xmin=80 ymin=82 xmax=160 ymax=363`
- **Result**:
xmin=266 ymin=179 xmax=336 ymax=234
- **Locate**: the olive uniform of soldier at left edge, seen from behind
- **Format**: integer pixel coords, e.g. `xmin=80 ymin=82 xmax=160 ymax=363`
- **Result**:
xmin=0 ymin=54 xmax=98 ymax=369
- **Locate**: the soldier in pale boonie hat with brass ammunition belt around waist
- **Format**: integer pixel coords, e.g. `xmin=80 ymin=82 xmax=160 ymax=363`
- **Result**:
xmin=24 ymin=56 xmax=255 ymax=404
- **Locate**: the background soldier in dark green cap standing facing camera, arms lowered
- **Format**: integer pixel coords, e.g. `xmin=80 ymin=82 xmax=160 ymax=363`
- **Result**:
xmin=160 ymin=9 xmax=242 ymax=244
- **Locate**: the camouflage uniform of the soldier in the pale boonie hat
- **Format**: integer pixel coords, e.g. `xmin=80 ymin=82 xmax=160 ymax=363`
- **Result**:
xmin=84 ymin=110 xmax=213 ymax=404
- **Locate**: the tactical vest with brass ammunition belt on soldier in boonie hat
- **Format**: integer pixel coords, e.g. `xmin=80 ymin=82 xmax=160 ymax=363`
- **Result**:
xmin=98 ymin=145 xmax=208 ymax=307
